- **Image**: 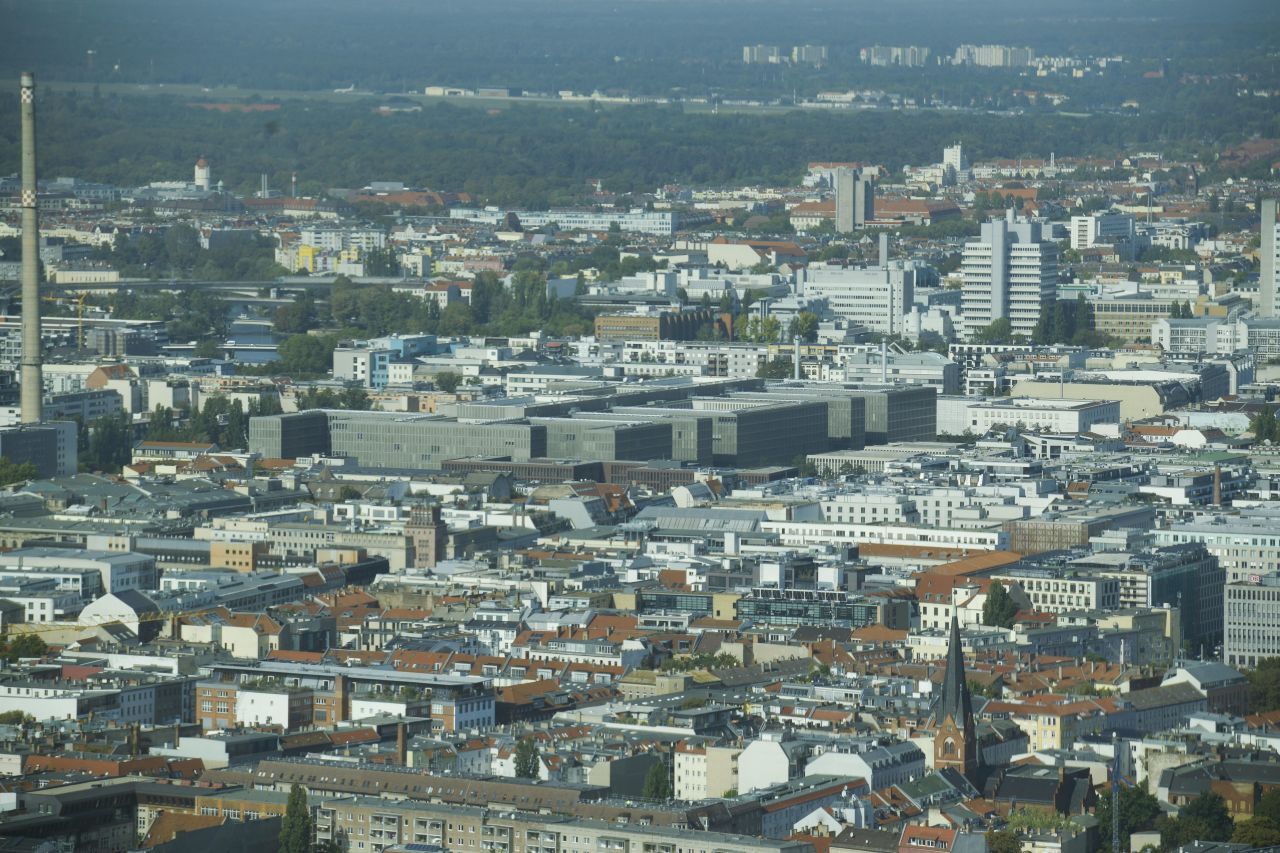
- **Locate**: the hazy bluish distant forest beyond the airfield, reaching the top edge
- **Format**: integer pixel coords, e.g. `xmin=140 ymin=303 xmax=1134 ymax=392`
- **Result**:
xmin=0 ymin=0 xmax=1280 ymax=95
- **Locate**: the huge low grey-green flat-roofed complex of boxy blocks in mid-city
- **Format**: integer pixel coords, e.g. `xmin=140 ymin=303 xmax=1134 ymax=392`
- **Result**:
xmin=250 ymin=380 xmax=937 ymax=470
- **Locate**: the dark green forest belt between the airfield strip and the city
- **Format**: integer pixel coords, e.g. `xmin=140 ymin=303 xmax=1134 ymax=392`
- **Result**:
xmin=0 ymin=92 xmax=1280 ymax=206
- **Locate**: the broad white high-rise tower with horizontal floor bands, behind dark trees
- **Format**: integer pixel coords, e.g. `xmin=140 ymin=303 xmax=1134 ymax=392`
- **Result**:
xmin=961 ymin=210 xmax=1057 ymax=341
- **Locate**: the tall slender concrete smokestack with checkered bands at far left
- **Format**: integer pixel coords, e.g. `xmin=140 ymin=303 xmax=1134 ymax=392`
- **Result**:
xmin=22 ymin=72 xmax=45 ymax=424
